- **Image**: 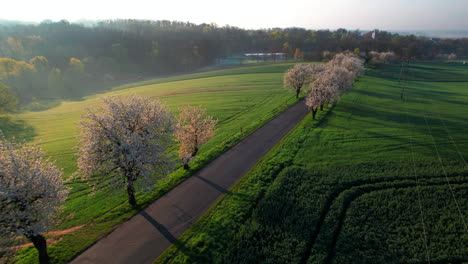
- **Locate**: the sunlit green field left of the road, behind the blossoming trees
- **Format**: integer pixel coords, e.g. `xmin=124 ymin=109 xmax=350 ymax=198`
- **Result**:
xmin=0 ymin=64 xmax=304 ymax=263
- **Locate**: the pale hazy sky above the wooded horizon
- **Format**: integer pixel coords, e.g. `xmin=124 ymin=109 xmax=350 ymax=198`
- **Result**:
xmin=0 ymin=0 xmax=468 ymax=30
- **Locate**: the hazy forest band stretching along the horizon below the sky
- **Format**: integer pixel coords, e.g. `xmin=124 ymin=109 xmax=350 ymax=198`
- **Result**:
xmin=0 ymin=20 xmax=468 ymax=104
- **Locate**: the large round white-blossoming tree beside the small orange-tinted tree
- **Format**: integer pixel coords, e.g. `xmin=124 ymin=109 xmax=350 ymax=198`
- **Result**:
xmin=78 ymin=95 xmax=174 ymax=206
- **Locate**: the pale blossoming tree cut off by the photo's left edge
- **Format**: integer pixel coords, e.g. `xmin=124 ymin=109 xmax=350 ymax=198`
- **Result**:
xmin=0 ymin=135 xmax=68 ymax=264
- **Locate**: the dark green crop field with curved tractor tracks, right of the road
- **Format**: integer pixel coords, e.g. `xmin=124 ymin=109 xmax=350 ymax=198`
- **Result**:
xmin=155 ymin=62 xmax=468 ymax=264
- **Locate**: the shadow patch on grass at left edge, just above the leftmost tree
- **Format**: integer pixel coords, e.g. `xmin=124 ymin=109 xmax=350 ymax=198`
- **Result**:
xmin=0 ymin=116 xmax=37 ymax=141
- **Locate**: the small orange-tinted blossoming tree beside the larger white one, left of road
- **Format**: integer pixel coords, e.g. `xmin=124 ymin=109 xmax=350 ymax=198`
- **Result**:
xmin=175 ymin=105 xmax=217 ymax=169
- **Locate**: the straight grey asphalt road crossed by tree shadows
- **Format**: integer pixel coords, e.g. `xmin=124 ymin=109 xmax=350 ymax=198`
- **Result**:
xmin=71 ymin=101 xmax=308 ymax=264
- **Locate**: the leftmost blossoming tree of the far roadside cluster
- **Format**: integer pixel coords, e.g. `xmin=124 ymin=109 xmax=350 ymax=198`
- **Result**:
xmin=283 ymin=64 xmax=313 ymax=98
